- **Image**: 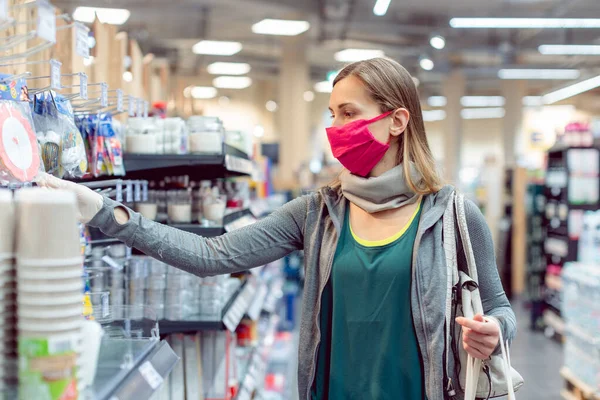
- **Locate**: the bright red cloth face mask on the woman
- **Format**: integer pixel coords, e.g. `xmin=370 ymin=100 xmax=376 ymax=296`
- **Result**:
xmin=326 ymin=111 xmax=392 ymax=177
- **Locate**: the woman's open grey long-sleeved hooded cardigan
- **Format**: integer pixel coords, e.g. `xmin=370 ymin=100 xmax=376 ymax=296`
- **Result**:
xmin=89 ymin=186 xmax=516 ymax=400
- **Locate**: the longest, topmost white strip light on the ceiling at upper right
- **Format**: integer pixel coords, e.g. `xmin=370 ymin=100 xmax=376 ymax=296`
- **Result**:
xmin=450 ymin=18 xmax=600 ymax=29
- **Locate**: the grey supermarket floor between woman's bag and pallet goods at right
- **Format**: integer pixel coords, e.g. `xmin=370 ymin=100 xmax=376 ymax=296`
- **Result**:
xmin=500 ymin=302 xmax=564 ymax=400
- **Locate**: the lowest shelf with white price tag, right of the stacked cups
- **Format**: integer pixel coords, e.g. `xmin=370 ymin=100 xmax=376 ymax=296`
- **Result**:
xmin=83 ymin=338 xmax=179 ymax=400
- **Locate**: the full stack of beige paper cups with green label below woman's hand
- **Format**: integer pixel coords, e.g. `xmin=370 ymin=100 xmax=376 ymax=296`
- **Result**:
xmin=15 ymin=188 xmax=83 ymax=400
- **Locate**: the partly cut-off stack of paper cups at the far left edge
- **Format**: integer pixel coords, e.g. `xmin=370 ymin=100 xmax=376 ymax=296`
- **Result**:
xmin=0 ymin=190 xmax=17 ymax=391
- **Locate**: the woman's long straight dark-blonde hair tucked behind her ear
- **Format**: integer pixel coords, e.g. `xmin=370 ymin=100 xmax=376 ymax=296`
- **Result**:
xmin=333 ymin=58 xmax=443 ymax=195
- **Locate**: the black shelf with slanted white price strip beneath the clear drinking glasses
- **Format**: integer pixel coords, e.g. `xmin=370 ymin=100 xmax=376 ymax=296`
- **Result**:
xmin=158 ymin=281 xmax=257 ymax=335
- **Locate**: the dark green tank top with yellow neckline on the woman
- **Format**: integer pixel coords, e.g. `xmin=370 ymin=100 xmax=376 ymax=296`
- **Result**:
xmin=311 ymin=206 xmax=425 ymax=400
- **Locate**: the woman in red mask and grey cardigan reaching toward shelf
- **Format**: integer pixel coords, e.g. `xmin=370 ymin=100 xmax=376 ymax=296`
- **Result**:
xmin=46 ymin=58 xmax=516 ymax=400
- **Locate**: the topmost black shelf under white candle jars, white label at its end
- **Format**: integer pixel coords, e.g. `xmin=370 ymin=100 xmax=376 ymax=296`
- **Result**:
xmin=123 ymin=145 xmax=254 ymax=178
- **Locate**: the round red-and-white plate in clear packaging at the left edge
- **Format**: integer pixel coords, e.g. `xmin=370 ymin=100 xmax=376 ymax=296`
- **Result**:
xmin=0 ymin=100 xmax=44 ymax=186
